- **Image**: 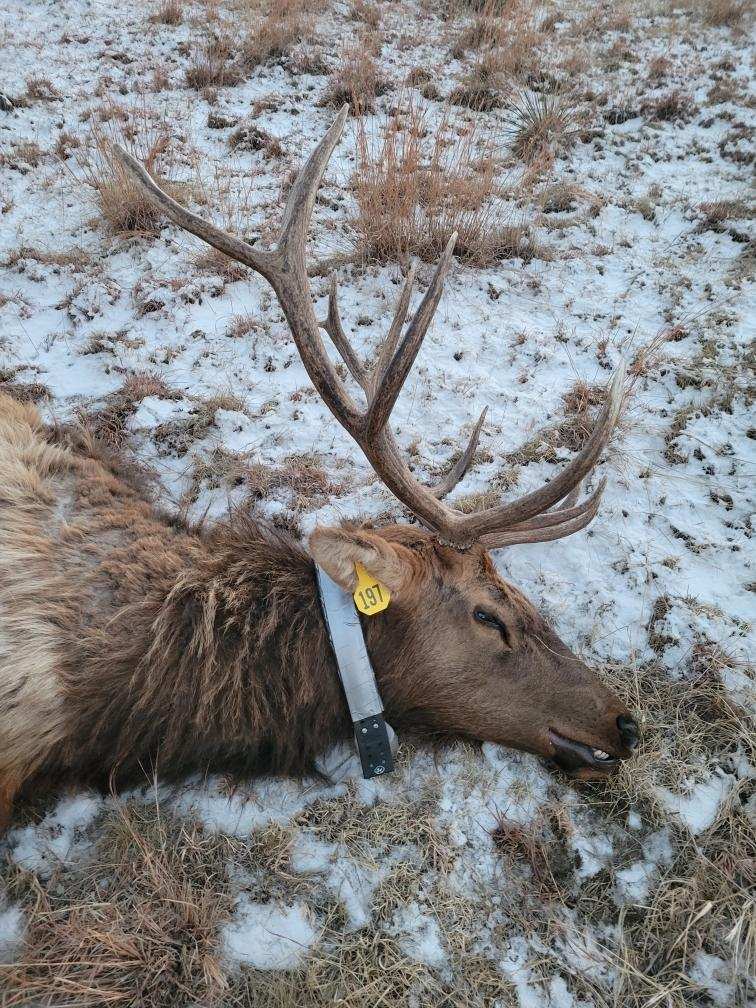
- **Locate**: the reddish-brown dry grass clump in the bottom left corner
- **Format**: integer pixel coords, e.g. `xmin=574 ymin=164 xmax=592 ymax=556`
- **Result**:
xmin=0 ymin=804 xmax=233 ymax=1008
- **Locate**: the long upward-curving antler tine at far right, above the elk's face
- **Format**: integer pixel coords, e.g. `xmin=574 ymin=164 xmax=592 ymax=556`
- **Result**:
xmin=459 ymin=363 xmax=625 ymax=540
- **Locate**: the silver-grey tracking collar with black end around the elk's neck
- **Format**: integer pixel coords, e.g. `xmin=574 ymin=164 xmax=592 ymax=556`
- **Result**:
xmin=316 ymin=563 xmax=396 ymax=778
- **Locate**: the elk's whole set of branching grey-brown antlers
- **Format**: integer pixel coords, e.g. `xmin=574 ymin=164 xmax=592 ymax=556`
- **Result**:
xmin=114 ymin=106 xmax=624 ymax=548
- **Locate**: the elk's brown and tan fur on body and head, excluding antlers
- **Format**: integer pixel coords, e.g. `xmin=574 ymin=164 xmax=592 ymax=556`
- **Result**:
xmin=0 ymin=394 xmax=624 ymax=827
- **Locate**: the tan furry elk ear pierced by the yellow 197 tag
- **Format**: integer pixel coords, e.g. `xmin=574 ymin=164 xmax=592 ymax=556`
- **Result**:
xmin=309 ymin=528 xmax=412 ymax=595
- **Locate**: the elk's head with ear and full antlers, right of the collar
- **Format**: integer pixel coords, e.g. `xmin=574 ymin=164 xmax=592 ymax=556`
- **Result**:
xmin=115 ymin=108 xmax=638 ymax=776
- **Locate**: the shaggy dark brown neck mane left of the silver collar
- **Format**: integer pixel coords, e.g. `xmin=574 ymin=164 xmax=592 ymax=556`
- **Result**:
xmin=56 ymin=515 xmax=351 ymax=784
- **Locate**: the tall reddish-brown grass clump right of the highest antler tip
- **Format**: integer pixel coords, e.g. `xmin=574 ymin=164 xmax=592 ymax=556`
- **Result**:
xmin=354 ymin=105 xmax=532 ymax=266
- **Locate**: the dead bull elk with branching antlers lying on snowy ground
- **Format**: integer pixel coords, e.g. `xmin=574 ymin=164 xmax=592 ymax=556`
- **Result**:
xmin=0 ymin=110 xmax=638 ymax=825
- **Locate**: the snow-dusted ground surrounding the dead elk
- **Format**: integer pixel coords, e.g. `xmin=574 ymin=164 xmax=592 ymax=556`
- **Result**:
xmin=0 ymin=0 xmax=756 ymax=1008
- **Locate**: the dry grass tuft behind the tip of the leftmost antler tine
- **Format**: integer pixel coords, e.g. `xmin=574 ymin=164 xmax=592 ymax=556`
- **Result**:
xmin=67 ymin=102 xmax=176 ymax=234
